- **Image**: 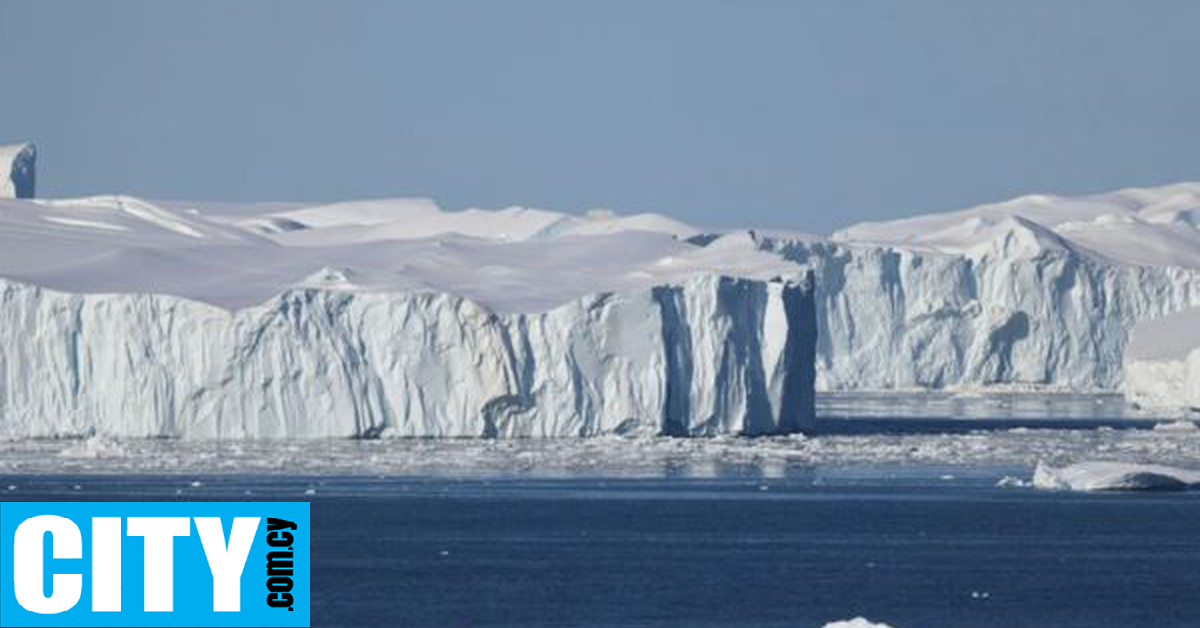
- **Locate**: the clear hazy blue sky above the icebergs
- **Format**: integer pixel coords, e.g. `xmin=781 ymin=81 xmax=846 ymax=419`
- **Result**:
xmin=0 ymin=0 xmax=1200 ymax=233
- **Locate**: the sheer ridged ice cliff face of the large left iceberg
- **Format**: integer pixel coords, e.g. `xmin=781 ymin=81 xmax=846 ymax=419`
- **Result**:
xmin=0 ymin=275 xmax=816 ymax=438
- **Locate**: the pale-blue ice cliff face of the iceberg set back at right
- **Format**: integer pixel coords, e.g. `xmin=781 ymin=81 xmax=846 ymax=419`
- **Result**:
xmin=758 ymin=231 xmax=1200 ymax=391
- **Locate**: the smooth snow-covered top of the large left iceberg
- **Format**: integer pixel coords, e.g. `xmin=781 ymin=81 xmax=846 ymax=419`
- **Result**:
xmin=7 ymin=196 xmax=748 ymax=313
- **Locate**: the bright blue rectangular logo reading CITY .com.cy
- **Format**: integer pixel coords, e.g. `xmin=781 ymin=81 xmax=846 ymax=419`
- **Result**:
xmin=0 ymin=502 xmax=311 ymax=628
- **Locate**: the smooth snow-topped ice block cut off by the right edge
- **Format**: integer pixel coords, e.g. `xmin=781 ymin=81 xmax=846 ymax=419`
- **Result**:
xmin=1124 ymin=309 xmax=1200 ymax=412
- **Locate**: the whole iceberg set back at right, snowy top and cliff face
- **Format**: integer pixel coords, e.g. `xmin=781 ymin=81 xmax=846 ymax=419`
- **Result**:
xmin=756 ymin=184 xmax=1200 ymax=391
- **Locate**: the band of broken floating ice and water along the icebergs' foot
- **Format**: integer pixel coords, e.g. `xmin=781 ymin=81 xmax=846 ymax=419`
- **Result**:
xmin=0 ymin=394 xmax=1200 ymax=480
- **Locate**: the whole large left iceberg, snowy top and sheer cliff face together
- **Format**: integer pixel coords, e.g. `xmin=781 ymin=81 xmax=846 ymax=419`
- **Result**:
xmin=0 ymin=197 xmax=815 ymax=438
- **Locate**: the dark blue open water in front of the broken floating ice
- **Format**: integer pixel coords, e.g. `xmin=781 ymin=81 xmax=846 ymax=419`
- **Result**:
xmin=0 ymin=475 xmax=1200 ymax=628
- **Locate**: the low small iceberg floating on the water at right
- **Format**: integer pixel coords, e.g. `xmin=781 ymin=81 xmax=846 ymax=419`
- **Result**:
xmin=1033 ymin=461 xmax=1200 ymax=491
